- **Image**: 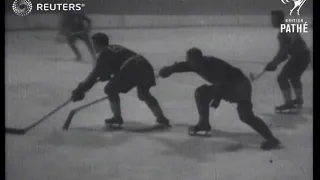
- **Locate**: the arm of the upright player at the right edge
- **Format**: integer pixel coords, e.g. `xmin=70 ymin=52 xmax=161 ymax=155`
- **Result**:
xmin=265 ymin=34 xmax=290 ymax=71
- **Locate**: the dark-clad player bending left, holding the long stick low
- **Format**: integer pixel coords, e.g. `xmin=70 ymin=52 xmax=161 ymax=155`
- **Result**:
xmin=72 ymin=33 xmax=170 ymax=127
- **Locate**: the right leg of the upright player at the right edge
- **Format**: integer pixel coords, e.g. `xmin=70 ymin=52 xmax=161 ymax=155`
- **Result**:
xmin=289 ymin=52 xmax=310 ymax=107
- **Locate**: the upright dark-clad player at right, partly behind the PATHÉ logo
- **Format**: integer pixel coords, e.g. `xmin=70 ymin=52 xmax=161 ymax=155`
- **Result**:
xmin=265 ymin=11 xmax=311 ymax=112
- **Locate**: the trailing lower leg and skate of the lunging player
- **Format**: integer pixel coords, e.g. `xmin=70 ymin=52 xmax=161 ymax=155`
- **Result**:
xmin=237 ymin=101 xmax=280 ymax=150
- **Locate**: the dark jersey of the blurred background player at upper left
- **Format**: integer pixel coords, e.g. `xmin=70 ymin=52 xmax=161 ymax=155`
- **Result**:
xmin=60 ymin=12 xmax=91 ymax=34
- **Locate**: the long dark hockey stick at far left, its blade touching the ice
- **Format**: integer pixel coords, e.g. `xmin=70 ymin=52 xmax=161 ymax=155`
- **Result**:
xmin=5 ymin=99 xmax=71 ymax=135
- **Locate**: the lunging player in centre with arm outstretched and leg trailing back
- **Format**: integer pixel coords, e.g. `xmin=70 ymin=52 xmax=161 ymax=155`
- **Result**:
xmin=159 ymin=48 xmax=280 ymax=150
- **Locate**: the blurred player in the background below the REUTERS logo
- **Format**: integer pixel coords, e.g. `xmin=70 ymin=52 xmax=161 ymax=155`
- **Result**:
xmin=59 ymin=12 xmax=96 ymax=64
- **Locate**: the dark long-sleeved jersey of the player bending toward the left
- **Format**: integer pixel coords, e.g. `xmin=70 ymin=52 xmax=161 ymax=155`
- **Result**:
xmin=77 ymin=45 xmax=137 ymax=91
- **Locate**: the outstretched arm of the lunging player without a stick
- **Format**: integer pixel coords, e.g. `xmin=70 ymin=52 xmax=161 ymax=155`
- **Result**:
xmin=159 ymin=62 xmax=194 ymax=78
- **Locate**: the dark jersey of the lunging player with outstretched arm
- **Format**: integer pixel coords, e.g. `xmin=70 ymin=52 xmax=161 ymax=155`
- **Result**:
xmin=171 ymin=56 xmax=246 ymax=84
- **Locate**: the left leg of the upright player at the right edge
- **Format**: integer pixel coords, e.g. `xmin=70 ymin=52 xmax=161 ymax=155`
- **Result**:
xmin=276 ymin=62 xmax=293 ymax=111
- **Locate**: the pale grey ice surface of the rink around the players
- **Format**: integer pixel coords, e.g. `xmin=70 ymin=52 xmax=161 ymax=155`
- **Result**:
xmin=5 ymin=27 xmax=313 ymax=180
